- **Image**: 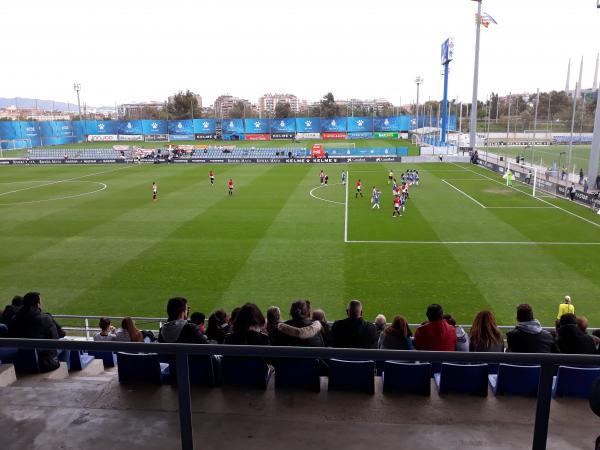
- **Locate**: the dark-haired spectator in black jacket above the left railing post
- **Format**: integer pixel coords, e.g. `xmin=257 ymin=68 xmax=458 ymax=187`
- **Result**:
xmin=158 ymin=297 xmax=208 ymax=344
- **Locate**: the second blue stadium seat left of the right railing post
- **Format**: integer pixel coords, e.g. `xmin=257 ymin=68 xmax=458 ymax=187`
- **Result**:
xmin=433 ymin=363 xmax=488 ymax=397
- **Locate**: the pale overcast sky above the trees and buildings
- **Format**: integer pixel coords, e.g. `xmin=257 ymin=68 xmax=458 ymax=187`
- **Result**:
xmin=0 ymin=0 xmax=600 ymax=106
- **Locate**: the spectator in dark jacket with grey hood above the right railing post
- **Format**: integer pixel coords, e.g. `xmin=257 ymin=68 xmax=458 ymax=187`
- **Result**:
xmin=506 ymin=303 xmax=558 ymax=353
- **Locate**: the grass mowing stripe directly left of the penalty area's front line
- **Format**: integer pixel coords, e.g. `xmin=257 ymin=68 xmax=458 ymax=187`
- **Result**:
xmin=217 ymin=167 xmax=344 ymax=316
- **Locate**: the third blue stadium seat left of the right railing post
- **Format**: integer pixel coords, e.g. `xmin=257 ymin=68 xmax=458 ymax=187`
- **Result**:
xmin=382 ymin=361 xmax=431 ymax=395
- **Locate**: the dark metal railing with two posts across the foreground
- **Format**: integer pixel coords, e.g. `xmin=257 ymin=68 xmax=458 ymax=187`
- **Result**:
xmin=0 ymin=338 xmax=600 ymax=450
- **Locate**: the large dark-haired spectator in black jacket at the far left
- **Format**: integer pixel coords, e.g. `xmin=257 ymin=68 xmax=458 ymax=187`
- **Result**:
xmin=8 ymin=292 xmax=65 ymax=372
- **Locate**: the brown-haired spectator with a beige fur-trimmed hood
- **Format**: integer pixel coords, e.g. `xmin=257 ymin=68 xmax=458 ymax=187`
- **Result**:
xmin=272 ymin=300 xmax=323 ymax=347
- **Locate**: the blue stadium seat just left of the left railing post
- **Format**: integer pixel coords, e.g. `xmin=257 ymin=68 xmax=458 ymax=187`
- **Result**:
xmin=117 ymin=352 xmax=169 ymax=384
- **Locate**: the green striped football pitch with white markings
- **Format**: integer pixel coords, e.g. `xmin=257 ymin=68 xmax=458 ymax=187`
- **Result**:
xmin=0 ymin=163 xmax=600 ymax=326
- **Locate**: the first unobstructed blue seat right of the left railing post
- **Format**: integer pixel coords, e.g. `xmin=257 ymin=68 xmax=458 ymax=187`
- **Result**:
xmin=221 ymin=356 xmax=273 ymax=389
